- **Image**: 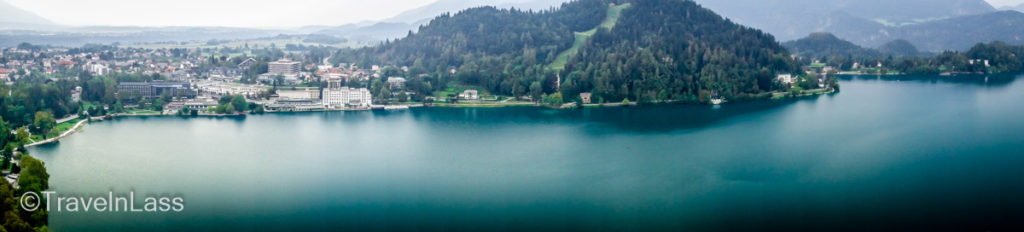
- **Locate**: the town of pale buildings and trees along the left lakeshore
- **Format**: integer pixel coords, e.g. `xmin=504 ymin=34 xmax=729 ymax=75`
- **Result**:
xmin=0 ymin=44 xmax=468 ymax=115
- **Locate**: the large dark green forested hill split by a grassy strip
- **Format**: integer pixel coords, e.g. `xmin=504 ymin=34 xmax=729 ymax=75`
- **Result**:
xmin=334 ymin=0 xmax=798 ymax=102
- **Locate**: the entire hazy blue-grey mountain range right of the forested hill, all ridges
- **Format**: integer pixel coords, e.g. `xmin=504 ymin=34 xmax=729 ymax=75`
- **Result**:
xmin=697 ymin=0 xmax=1024 ymax=52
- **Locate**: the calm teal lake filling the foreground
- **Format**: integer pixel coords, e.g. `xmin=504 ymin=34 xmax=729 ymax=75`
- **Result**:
xmin=30 ymin=76 xmax=1024 ymax=231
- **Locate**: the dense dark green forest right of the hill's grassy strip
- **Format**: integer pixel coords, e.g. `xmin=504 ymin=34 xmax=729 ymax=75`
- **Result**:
xmin=561 ymin=1 xmax=798 ymax=102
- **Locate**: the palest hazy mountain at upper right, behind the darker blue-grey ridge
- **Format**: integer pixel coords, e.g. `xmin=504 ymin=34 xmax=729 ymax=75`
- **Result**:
xmin=697 ymin=0 xmax=995 ymax=42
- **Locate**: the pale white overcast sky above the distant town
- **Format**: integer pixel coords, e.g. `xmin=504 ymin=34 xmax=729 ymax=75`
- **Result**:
xmin=7 ymin=0 xmax=1024 ymax=28
